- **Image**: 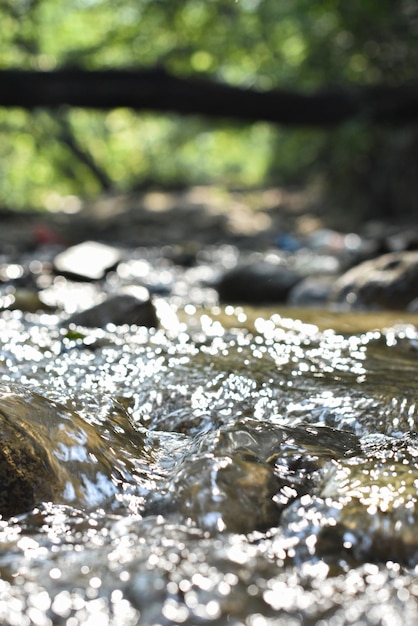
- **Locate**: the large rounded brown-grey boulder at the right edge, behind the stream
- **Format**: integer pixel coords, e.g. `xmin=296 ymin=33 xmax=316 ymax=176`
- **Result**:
xmin=330 ymin=252 xmax=418 ymax=310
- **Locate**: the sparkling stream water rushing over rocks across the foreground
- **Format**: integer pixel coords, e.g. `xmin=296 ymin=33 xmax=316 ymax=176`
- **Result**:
xmin=0 ymin=307 xmax=418 ymax=626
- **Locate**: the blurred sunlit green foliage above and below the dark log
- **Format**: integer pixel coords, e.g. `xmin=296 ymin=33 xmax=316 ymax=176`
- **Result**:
xmin=0 ymin=0 xmax=418 ymax=215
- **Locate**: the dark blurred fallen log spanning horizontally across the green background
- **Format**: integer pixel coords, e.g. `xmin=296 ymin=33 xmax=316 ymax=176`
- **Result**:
xmin=0 ymin=68 xmax=418 ymax=127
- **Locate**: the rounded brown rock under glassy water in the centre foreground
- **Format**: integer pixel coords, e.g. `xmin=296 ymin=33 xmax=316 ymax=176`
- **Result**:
xmin=158 ymin=429 xmax=288 ymax=533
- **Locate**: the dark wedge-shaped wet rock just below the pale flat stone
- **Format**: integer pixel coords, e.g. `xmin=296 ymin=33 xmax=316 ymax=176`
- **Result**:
xmin=64 ymin=287 xmax=158 ymax=328
